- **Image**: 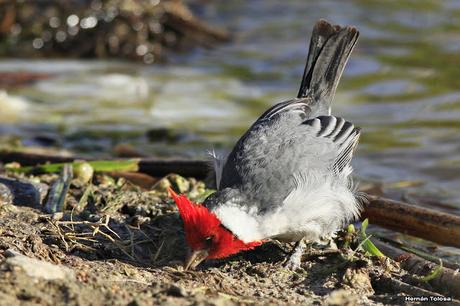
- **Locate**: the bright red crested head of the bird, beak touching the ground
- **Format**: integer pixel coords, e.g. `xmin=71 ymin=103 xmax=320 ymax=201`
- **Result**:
xmin=169 ymin=188 xmax=262 ymax=269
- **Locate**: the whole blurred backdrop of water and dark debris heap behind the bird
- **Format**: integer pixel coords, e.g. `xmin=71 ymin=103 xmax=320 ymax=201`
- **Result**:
xmin=0 ymin=0 xmax=460 ymax=213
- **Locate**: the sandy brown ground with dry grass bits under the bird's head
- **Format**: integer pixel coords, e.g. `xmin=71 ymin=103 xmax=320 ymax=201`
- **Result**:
xmin=0 ymin=175 xmax=424 ymax=305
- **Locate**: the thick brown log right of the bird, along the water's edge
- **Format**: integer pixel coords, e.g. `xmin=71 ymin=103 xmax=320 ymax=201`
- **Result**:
xmin=361 ymin=195 xmax=460 ymax=247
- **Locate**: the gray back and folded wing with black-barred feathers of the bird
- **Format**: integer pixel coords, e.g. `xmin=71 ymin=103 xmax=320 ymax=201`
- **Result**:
xmin=219 ymin=112 xmax=360 ymax=211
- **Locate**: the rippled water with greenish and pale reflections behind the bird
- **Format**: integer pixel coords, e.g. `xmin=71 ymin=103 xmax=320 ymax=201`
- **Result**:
xmin=0 ymin=0 xmax=460 ymax=207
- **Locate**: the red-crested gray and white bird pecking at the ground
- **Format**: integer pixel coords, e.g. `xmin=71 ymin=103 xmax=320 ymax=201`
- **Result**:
xmin=169 ymin=19 xmax=361 ymax=269
